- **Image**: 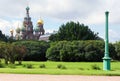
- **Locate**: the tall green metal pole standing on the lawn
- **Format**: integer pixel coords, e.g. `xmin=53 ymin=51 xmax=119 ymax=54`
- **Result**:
xmin=103 ymin=11 xmax=111 ymax=70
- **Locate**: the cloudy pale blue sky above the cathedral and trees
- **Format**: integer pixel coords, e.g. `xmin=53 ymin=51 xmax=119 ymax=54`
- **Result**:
xmin=0 ymin=0 xmax=120 ymax=42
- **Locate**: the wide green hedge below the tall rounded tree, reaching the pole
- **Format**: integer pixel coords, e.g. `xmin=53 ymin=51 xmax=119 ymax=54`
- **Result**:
xmin=46 ymin=41 xmax=116 ymax=62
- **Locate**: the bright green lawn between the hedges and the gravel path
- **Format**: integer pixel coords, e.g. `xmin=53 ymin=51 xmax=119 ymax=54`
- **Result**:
xmin=0 ymin=61 xmax=120 ymax=76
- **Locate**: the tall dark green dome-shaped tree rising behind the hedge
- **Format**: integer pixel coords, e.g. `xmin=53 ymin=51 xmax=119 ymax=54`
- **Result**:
xmin=49 ymin=21 xmax=101 ymax=41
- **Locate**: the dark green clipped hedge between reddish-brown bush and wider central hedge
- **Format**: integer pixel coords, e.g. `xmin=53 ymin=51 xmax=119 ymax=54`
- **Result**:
xmin=14 ymin=41 xmax=49 ymax=61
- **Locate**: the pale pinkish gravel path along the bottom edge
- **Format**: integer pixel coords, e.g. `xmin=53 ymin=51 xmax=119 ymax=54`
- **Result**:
xmin=0 ymin=74 xmax=120 ymax=81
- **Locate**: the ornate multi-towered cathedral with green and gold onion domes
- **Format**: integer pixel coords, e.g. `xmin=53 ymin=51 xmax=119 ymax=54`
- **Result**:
xmin=14 ymin=6 xmax=45 ymax=40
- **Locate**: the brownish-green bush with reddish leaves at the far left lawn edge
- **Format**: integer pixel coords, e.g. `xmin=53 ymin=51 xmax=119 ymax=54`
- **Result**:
xmin=0 ymin=42 xmax=26 ymax=64
